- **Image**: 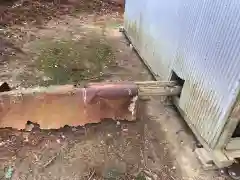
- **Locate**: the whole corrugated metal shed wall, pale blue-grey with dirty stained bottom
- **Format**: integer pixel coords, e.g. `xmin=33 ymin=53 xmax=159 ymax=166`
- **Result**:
xmin=124 ymin=0 xmax=240 ymax=148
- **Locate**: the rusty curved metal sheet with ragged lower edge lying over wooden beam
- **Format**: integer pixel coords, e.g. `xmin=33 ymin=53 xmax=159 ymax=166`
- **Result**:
xmin=0 ymin=83 xmax=138 ymax=129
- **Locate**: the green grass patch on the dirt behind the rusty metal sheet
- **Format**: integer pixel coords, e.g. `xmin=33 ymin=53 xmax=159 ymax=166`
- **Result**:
xmin=37 ymin=37 xmax=115 ymax=85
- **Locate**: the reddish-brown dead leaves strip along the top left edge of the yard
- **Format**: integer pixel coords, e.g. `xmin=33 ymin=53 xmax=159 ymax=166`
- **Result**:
xmin=0 ymin=0 xmax=123 ymax=27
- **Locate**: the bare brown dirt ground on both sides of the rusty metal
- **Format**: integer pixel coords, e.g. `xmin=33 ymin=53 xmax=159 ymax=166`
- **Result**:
xmin=0 ymin=0 xmax=230 ymax=180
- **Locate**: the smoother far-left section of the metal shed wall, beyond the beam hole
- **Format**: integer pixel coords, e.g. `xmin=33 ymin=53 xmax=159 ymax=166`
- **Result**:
xmin=124 ymin=0 xmax=179 ymax=79
